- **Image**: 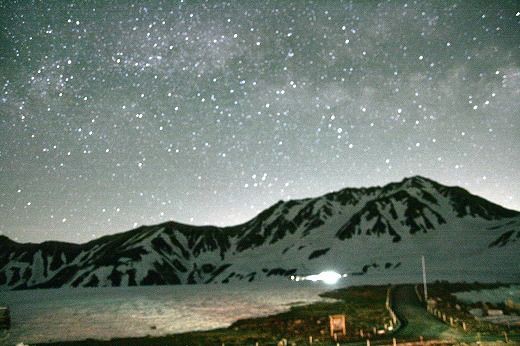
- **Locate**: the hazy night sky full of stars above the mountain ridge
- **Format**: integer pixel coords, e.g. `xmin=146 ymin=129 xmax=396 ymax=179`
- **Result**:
xmin=0 ymin=0 xmax=520 ymax=242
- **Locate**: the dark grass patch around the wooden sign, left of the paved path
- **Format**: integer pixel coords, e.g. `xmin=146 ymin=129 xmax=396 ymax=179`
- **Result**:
xmin=36 ymin=286 xmax=390 ymax=346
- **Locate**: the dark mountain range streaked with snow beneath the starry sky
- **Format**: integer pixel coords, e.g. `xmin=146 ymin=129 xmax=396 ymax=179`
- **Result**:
xmin=0 ymin=176 xmax=520 ymax=289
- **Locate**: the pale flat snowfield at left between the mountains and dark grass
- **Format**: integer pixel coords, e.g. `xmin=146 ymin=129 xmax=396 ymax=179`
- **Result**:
xmin=0 ymin=279 xmax=334 ymax=345
